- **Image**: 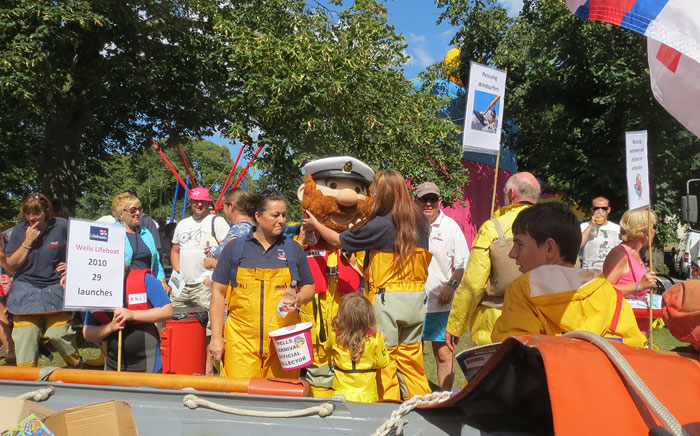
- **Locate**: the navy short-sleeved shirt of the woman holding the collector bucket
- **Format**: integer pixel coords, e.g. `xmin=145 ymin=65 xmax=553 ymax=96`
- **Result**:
xmin=212 ymin=233 xmax=314 ymax=286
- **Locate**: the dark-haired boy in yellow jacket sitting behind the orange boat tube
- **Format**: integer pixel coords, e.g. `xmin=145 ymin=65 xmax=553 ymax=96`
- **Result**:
xmin=491 ymin=203 xmax=646 ymax=347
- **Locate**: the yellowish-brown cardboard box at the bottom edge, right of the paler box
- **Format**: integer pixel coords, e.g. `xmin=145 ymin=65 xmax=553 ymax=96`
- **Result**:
xmin=43 ymin=400 xmax=137 ymax=436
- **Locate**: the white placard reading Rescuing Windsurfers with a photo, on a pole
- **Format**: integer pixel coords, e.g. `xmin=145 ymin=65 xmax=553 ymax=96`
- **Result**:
xmin=462 ymin=62 xmax=506 ymax=154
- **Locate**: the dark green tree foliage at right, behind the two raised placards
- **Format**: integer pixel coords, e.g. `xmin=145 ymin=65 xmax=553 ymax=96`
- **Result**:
xmin=439 ymin=0 xmax=700 ymax=244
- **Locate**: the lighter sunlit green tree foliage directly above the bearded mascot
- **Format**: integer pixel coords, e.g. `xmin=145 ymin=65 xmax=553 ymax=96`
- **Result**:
xmin=217 ymin=0 xmax=465 ymax=202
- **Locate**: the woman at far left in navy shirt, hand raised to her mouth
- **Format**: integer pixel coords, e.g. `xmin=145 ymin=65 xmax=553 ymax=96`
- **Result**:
xmin=5 ymin=194 xmax=81 ymax=367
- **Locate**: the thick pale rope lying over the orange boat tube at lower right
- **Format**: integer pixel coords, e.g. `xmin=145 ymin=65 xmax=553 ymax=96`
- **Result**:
xmin=564 ymin=331 xmax=687 ymax=436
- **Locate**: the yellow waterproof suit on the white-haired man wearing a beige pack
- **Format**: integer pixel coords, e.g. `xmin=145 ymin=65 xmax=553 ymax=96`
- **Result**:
xmin=446 ymin=204 xmax=529 ymax=338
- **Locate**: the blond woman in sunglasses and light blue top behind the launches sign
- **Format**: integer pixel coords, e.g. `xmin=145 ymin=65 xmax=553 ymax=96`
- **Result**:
xmin=112 ymin=192 xmax=170 ymax=293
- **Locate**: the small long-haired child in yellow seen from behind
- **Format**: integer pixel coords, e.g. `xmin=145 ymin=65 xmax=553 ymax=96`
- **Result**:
xmin=324 ymin=293 xmax=389 ymax=403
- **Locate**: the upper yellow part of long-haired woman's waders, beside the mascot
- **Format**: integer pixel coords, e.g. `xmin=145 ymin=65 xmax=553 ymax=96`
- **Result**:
xmin=365 ymin=247 xmax=433 ymax=301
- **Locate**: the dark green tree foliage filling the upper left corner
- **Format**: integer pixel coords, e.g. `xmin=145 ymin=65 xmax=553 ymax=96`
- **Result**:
xmin=0 ymin=0 xmax=231 ymax=216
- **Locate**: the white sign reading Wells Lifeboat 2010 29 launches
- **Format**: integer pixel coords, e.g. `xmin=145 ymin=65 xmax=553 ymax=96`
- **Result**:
xmin=63 ymin=218 xmax=126 ymax=310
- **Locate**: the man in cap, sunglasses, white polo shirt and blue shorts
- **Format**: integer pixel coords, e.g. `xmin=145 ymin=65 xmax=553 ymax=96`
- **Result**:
xmin=415 ymin=182 xmax=469 ymax=391
